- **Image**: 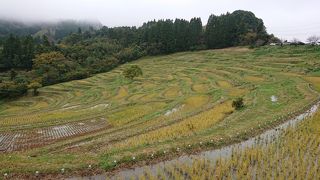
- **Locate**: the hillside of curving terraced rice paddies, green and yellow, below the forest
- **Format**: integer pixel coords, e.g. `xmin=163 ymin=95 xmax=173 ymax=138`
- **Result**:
xmin=0 ymin=47 xmax=320 ymax=177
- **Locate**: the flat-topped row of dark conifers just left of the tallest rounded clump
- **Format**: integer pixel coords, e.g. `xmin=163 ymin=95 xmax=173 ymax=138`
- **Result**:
xmin=138 ymin=18 xmax=204 ymax=55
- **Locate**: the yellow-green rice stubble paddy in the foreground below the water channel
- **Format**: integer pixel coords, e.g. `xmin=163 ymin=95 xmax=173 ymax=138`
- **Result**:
xmin=139 ymin=107 xmax=320 ymax=179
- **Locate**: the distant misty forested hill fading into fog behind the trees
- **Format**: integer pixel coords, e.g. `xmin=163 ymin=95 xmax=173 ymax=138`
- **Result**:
xmin=0 ymin=19 xmax=102 ymax=41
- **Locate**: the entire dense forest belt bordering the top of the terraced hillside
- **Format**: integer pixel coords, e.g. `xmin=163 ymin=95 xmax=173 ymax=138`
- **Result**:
xmin=0 ymin=10 xmax=277 ymax=98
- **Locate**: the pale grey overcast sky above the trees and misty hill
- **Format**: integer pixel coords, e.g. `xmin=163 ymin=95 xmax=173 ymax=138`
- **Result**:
xmin=0 ymin=0 xmax=320 ymax=40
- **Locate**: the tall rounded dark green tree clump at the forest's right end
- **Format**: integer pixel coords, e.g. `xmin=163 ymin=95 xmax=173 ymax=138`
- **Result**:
xmin=205 ymin=11 xmax=274 ymax=48
